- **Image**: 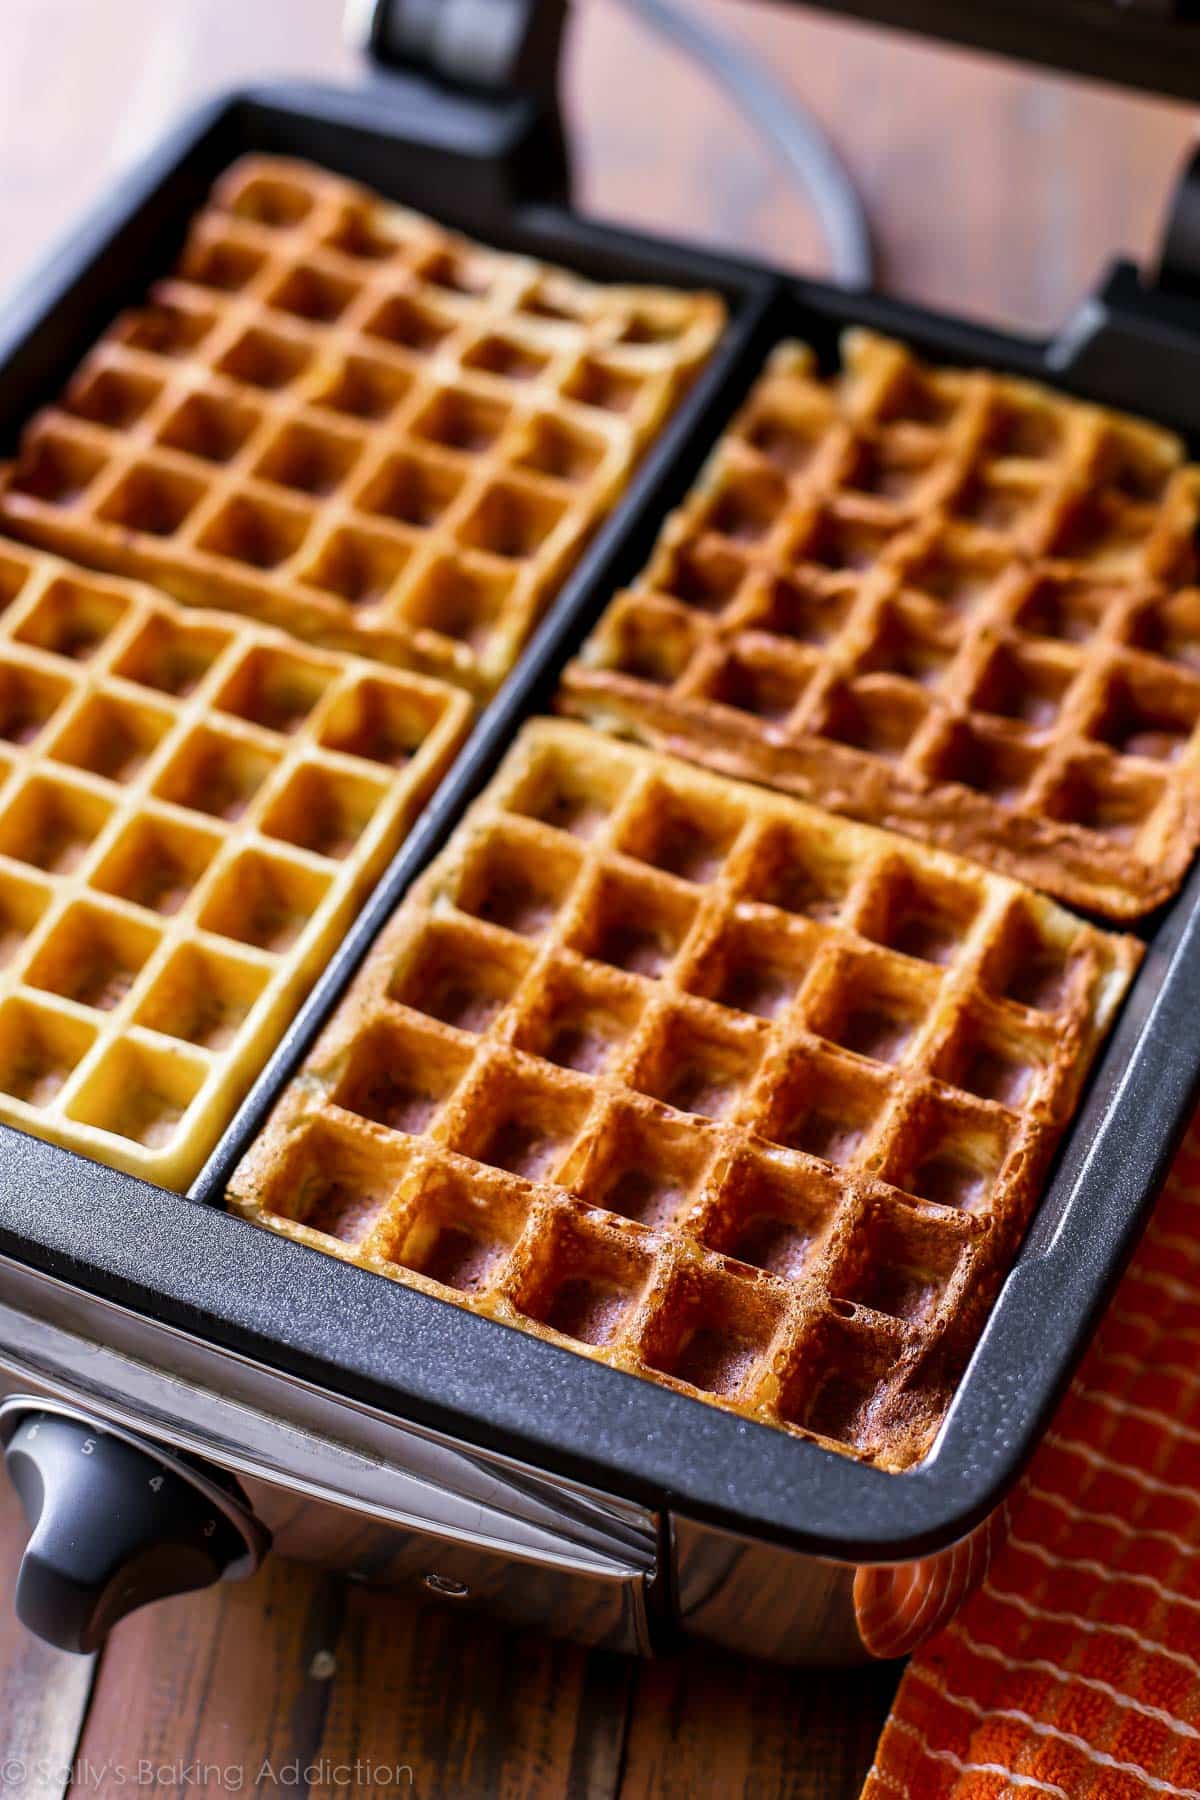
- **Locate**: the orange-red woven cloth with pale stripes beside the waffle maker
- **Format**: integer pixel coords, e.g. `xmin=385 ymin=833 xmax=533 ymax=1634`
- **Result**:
xmin=864 ymin=1121 xmax=1200 ymax=1800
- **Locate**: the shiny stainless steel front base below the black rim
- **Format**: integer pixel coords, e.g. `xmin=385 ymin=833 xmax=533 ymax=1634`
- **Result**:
xmin=0 ymin=1258 xmax=981 ymax=1665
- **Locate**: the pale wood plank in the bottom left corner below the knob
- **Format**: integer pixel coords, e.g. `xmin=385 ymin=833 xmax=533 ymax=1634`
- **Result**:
xmin=0 ymin=1480 xmax=95 ymax=1800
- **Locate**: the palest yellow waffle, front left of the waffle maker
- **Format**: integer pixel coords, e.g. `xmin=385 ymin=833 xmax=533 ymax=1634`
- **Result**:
xmin=0 ymin=542 xmax=471 ymax=1190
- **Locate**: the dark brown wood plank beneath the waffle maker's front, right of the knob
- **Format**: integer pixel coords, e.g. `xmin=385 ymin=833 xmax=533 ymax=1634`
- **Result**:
xmin=79 ymin=1561 xmax=633 ymax=1800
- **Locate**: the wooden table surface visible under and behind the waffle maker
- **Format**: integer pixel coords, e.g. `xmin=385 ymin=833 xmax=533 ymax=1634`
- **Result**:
xmin=0 ymin=0 xmax=1191 ymax=1800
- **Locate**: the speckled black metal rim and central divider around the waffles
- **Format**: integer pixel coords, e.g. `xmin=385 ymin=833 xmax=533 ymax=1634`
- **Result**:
xmin=0 ymin=73 xmax=1200 ymax=1561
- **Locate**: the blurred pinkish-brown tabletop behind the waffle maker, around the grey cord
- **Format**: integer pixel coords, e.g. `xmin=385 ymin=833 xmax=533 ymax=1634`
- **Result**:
xmin=567 ymin=0 xmax=1195 ymax=328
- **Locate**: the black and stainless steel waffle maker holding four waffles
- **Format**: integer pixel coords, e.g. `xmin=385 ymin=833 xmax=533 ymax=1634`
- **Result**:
xmin=0 ymin=0 xmax=1200 ymax=1665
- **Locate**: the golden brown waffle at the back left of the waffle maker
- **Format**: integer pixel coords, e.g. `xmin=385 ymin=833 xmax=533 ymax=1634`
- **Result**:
xmin=0 ymin=157 xmax=725 ymax=691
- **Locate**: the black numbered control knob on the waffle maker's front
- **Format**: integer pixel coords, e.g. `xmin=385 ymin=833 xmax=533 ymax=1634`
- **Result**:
xmin=0 ymin=1397 xmax=266 ymax=1652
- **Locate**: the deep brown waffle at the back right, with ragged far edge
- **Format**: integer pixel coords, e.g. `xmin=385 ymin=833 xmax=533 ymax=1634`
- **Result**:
xmin=563 ymin=331 xmax=1200 ymax=918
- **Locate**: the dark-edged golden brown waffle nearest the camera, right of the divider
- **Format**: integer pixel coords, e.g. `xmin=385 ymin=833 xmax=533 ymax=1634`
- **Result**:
xmin=230 ymin=722 xmax=1139 ymax=1469
